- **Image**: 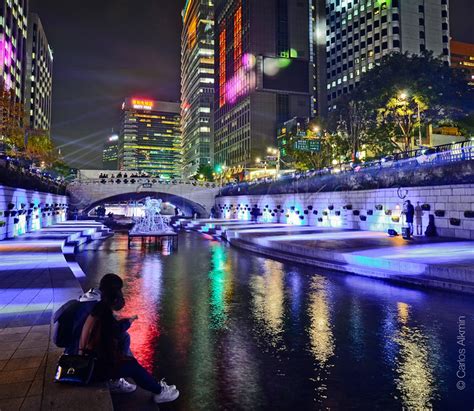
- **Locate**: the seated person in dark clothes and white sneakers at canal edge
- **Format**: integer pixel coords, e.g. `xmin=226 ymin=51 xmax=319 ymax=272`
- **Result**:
xmin=79 ymin=290 xmax=179 ymax=404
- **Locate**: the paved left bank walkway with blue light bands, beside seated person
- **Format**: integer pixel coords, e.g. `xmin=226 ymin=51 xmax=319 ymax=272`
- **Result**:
xmin=0 ymin=222 xmax=112 ymax=411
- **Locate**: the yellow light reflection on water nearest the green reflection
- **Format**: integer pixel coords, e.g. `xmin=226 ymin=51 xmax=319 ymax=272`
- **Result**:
xmin=250 ymin=260 xmax=285 ymax=350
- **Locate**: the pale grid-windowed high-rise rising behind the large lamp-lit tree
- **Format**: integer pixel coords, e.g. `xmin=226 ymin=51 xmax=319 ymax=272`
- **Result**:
xmin=315 ymin=0 xmax=450 ymax=112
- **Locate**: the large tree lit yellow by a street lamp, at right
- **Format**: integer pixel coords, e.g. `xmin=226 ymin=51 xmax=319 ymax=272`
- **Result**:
xmin=329 ymin=53 xmax=474 ymax=161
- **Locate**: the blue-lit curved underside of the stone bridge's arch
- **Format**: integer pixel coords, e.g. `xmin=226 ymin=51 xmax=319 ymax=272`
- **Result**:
xmin=83 ymin=191 xmax=208 ymax=218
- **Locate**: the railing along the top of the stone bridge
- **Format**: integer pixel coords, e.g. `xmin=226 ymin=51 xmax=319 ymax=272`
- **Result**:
xmin=71 ymin=177 xmax=221 ymax=188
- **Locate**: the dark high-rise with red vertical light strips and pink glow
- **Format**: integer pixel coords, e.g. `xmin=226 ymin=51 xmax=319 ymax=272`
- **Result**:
xmin=214 ymin=0 xmax=314 ymax=172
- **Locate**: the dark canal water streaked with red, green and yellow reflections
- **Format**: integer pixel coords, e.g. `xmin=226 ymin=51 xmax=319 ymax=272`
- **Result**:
xmin=78 ymin=233 xmax=474 ymax=411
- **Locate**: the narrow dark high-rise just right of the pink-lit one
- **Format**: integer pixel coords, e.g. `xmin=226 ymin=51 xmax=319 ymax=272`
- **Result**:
xmin=25 ymin=13 xmax=53 ymax=130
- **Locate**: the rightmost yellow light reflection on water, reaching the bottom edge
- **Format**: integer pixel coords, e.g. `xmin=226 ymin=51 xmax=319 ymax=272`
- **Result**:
xmin=395 ymin=302 xmax=435 ymax=410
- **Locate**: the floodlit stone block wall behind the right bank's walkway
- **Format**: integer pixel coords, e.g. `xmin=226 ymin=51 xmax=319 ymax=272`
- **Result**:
xmin=216 ymin=184 xmax=474 ymax=240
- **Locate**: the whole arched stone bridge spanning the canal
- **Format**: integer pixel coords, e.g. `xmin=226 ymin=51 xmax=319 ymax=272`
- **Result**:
xmin=68 ymin=178 xmax=220 ymax=217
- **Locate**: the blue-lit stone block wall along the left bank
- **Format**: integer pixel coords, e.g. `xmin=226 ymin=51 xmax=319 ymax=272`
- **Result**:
xmin=0 ymin=185 xmax=69 ymax=240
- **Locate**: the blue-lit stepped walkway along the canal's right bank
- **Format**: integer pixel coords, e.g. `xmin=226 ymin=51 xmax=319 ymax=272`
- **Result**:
xmin=190 ymin=224 xmax=474 ymax=294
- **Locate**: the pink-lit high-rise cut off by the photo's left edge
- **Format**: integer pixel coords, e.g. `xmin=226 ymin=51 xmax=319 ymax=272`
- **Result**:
xmin=0 ymin=0 xmax=28 ymax=102
